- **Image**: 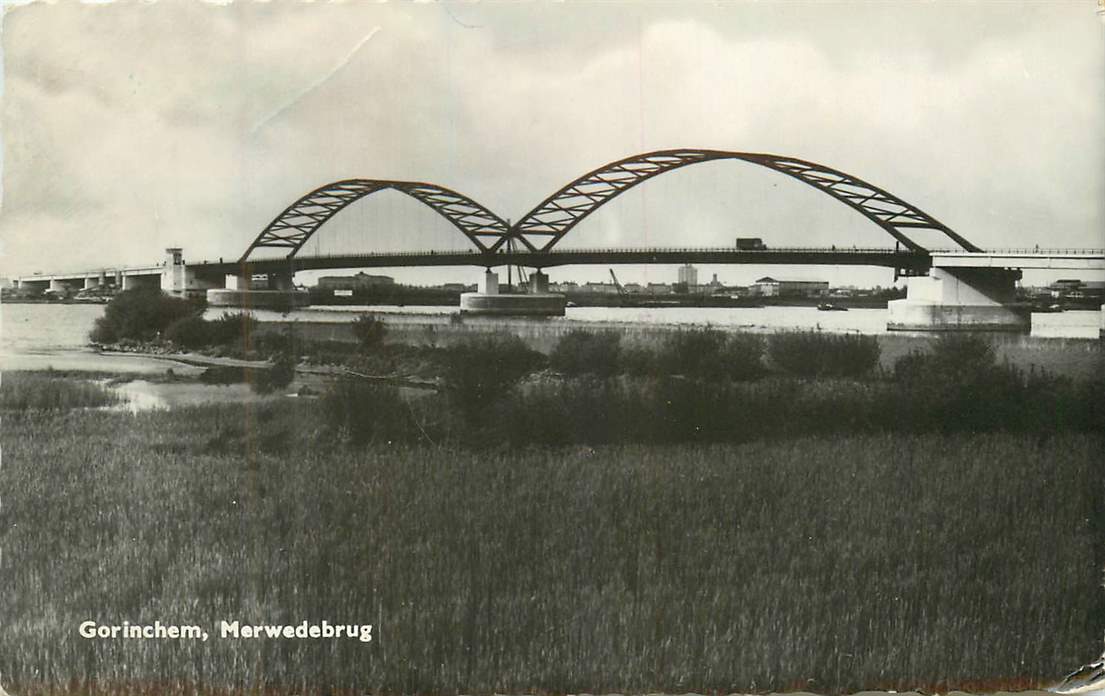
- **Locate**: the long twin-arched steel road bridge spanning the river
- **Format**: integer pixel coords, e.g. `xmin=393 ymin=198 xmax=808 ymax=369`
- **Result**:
xmin=19 ymin=149 xmax=1105 ymax=330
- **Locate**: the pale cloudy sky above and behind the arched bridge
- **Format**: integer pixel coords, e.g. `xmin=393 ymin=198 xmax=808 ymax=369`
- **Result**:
xmin=0 ymin=0 xmax=1105 ymax=283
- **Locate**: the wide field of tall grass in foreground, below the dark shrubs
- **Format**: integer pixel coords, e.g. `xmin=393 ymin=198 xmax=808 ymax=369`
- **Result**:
xmin=0 ymin=403 xmax=1105 ymax=695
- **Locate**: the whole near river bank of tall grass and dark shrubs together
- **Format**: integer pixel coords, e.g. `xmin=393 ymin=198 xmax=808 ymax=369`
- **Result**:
xmin=0 ymin=291 xmax=1105 ymax=695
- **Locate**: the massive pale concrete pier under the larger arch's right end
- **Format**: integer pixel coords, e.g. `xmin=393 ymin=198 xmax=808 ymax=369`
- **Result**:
xmin=886 ymin=267 xmax=1032 ymax=333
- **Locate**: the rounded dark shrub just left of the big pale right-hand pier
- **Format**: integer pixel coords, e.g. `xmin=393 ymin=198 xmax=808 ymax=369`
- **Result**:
xmin=768 ymin=331 xmax=880 ymax=377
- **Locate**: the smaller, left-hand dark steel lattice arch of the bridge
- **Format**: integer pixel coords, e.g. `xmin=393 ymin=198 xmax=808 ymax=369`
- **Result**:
xmin=239 ymin=179 xmax=508 ymax=263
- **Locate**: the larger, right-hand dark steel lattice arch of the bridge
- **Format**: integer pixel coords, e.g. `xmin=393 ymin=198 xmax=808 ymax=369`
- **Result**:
xmin=506 ymin=149 xmax=982 ymax=252
